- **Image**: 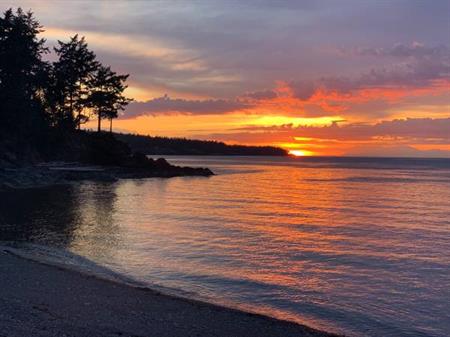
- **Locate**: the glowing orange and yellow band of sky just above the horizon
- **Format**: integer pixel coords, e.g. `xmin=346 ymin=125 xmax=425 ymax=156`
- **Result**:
xmin=88 ymin=81 xmax=450 ymax=156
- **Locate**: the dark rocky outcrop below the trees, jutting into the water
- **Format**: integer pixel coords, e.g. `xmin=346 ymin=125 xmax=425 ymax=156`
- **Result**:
xmin=0 ymin=131 xmax=213 ymax=189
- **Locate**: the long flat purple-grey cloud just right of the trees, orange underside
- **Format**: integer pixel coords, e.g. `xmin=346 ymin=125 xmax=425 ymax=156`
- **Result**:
xmin=121 ymin=95 xmax=251 ymax=119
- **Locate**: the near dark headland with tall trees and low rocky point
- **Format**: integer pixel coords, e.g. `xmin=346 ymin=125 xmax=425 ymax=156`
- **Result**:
xmin=0 ymin=8 xmax=212 ymax=180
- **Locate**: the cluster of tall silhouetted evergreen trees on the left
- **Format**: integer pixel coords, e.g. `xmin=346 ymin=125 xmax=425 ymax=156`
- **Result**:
xmin=0 ymin=8 xmax=131 ymax=163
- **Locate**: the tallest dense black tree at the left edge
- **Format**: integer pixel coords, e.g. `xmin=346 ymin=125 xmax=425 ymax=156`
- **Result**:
xmin=0 ymin=8 xmax=48 ymax=139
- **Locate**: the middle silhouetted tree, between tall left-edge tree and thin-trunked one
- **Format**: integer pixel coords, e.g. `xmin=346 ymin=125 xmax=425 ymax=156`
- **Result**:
xmin=53 ymin=34 xmax=99 ymax=129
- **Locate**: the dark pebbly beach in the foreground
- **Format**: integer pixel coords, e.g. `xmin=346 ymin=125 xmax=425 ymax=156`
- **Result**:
xmin=0 ymin=246 xmax=338 ymax=337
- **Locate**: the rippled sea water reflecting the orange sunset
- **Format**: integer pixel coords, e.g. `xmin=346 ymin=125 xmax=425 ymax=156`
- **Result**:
xmin=0 ymin=157 xmax=450 ymax=337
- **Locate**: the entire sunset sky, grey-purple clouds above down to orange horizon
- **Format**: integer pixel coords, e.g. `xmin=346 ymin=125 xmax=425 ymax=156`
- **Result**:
xmin=7 ymin=0 xmax=450 ymax=157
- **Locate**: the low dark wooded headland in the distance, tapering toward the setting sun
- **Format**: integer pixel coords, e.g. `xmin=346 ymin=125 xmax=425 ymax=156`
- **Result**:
xmin=115 ymin=133 xmax=287 ymax=156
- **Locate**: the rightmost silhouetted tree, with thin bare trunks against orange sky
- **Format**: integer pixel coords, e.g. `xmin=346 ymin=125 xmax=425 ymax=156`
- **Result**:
xmin=87 ymin=66 xmax=131 ymax=132
